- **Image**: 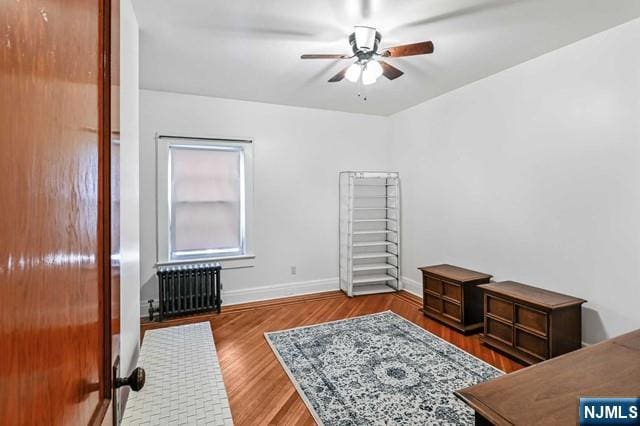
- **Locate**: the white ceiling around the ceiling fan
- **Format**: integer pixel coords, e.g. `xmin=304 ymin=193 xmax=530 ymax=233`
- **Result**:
xmin=134 ymin=0 xmax=640 ymax=115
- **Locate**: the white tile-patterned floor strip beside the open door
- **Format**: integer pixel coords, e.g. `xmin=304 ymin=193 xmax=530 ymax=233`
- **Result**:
xmin=122 ymin=322 xmax=233 ymax=426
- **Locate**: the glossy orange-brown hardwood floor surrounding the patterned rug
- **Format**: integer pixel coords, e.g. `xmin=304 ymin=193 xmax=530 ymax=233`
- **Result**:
xmin=142 ymin=292 xmax=522 ymax=425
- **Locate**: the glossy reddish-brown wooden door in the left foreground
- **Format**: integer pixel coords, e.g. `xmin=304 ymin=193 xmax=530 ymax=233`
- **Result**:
xmin=0 ymin=0 xmax=119 ymax=425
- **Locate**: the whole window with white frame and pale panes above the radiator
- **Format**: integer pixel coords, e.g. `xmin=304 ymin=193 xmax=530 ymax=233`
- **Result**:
xmin=158 ymin=136 xmax=253 ymax=266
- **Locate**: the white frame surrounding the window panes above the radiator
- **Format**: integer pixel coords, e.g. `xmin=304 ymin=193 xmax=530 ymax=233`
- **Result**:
xmin=156 ymin=134 xmax=255 ymax=268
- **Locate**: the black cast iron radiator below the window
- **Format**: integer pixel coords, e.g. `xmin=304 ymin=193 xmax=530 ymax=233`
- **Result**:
xmin=157 ymin=263 xmax=222 ymax=321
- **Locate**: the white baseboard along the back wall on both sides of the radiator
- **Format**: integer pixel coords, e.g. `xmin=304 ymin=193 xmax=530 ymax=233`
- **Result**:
xmin=140 ymin=277 xmax=340 ymax=318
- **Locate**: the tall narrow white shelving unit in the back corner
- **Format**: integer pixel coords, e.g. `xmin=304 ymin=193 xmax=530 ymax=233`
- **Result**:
xmin=339 ymin=171 xmax=402 ymax=296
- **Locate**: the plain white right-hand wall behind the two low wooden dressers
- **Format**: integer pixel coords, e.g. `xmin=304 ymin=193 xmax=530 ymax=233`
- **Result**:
xmin=389 ymin=20 xmax=640 ymax=342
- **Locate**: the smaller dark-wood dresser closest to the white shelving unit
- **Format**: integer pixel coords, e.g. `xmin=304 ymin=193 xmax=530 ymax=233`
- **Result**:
xmin=418 ymin=265 xmax=491 ymax=333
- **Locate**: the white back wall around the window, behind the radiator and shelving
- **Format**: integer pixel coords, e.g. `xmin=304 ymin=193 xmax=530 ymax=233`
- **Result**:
xmin=140 ymin=90 xmax=389 ymax=315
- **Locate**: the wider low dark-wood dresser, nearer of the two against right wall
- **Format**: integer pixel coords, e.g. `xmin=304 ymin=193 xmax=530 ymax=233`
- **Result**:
xmin=478 ymin=281 xmax=586 ymax=364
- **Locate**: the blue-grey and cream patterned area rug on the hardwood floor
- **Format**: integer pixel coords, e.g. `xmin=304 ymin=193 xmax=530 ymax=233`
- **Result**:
xmin=265 ymin=311 xmax=502 ymax=426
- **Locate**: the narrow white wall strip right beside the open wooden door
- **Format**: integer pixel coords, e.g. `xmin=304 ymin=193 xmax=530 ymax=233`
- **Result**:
xmin=120 ymin=0 xmax=140 ymax=376
